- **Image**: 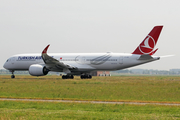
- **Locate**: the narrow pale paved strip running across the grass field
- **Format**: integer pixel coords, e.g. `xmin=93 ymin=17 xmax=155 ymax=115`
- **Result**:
xmin=0 ymin=98 xmax=180 ymax=106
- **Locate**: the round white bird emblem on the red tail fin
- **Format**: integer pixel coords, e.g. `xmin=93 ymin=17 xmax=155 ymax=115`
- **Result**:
xmin=139 ymin=35 xmax=155 ymax=54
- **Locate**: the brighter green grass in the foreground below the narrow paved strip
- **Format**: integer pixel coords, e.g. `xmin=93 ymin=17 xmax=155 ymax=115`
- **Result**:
xmin=0 ymin=101 xmax=180 ymax=120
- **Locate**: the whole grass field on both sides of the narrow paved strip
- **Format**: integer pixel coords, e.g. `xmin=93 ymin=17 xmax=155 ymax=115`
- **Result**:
xmin=0 ymin=75 xmax=180 ymax=120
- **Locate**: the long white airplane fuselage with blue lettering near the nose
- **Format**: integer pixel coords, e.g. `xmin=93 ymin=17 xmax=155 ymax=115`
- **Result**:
xmin=4 ymin=53 xmax=159 ymax=73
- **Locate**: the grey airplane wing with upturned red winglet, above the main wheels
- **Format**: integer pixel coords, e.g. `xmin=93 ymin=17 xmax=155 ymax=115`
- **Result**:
xmin=41 ymin=45 xmax=76 ymax=73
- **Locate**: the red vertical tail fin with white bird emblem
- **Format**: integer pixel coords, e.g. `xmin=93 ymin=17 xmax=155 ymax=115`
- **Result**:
xmin=132 ymin=26 xmax=163 ymax=55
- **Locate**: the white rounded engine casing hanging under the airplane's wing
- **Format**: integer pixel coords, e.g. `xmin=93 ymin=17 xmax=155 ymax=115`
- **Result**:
xmin=29 ymin=64 xmax=49 ymax=76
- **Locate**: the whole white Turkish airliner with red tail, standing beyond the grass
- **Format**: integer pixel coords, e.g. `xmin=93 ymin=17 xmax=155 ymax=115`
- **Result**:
xmin=3 ymin=26 xmax=163 ymax=79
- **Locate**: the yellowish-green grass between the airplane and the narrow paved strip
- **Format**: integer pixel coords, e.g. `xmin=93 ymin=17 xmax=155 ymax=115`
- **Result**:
xmin=0 ymin=76 xmax=180 ymax=102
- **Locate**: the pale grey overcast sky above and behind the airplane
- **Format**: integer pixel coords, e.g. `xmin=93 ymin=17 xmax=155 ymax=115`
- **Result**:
xmin=0 ymin=0 xmax=180 ymax=70
